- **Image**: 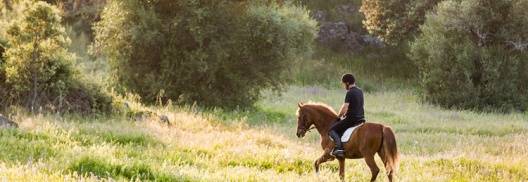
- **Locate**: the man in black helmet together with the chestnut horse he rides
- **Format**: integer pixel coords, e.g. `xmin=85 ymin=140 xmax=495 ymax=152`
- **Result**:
xmin=296 ymin=74 xmax=399 ymax=181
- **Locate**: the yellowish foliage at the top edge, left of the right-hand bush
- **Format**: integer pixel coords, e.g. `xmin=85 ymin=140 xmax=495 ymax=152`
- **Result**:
xmin=361 ymin=0 xmax=442 ymax=44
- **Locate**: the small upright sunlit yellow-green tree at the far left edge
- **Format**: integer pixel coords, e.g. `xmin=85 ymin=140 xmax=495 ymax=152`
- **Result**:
xmin=3 ymin=2 xmax=73 ymax=109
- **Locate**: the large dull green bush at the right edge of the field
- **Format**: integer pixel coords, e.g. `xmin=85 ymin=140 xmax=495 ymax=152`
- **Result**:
xmin=411 ymin=0 xmax=528 ymax=111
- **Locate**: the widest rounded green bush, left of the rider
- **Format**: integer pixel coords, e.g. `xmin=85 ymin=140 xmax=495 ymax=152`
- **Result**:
xmin=95 ymin=0 xmax=316 ymax=108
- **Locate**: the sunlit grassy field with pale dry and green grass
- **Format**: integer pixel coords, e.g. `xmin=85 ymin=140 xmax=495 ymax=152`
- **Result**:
xmin=0 ymin=86 xmax=528 ymax=181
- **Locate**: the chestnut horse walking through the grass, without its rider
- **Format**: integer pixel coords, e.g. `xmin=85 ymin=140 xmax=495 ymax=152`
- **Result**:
xmin=297 ymin=103 xmax=399 ymax=181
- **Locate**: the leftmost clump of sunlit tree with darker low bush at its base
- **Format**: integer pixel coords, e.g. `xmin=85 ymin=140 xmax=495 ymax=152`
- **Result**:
xmin=0 ymin=2 xmax=111 ymax=113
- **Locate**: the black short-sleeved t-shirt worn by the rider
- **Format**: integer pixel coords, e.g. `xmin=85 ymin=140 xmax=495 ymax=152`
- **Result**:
xmin=345 ymin=87 xmax=365 ymax=121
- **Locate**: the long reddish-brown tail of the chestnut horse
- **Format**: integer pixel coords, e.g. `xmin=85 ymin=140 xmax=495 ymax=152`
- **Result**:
xmin=381 ymin=126 xmax=400 ymax=174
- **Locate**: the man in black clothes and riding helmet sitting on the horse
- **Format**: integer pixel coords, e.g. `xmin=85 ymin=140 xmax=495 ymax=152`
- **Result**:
xmin=329 ymin=74 xmax=365 ymax=158
